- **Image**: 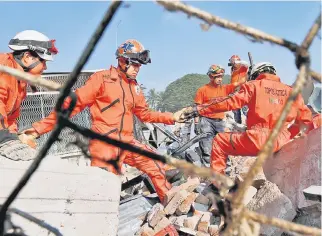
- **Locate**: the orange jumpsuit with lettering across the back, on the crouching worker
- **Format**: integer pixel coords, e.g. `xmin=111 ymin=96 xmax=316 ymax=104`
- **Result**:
xmin=197 ymin=74 xmax=312 ymax=173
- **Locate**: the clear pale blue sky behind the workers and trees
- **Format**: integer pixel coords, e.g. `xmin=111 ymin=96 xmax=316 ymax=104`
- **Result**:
xmin=0 ymin=1 xmax=321 ymax=90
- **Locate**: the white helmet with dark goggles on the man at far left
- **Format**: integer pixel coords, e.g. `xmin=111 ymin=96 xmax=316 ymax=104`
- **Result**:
xmin=8 ymin=30 xmax=58 ymax=61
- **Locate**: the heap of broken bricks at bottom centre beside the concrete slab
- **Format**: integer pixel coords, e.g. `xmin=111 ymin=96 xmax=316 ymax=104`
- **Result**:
xmin=136 ymin=178 xmax=224 ymax=236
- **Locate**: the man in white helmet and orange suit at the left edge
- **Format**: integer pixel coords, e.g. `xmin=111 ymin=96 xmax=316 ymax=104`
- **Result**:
xmin=0 ymin=30 xmax=58 ymax=161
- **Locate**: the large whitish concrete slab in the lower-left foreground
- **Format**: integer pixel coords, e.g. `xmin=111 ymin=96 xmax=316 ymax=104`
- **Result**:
xmin=0 ymin=156 xmax=121 ymax=236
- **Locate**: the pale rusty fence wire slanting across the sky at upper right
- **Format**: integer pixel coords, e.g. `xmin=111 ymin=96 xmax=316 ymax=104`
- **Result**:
xmin=156 ymin=0 xmax=321 ymax=83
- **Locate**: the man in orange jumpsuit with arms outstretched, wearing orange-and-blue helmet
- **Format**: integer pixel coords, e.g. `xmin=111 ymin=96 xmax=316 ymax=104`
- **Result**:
xmin=20 ymin=39 xmax=184 ymax=202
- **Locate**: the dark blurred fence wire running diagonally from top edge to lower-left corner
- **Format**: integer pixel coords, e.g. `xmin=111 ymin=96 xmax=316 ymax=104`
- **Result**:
xmin=0 ymin=1 xmax=122 ymax=235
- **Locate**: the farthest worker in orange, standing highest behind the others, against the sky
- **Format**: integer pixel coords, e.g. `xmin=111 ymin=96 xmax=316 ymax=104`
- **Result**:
xmin=228 ymin=55 xmax=248 ymax=124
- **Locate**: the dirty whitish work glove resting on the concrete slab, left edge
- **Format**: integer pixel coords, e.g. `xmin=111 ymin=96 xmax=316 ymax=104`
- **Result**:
xmin=0 ymin=139 xmax=37 ymax=161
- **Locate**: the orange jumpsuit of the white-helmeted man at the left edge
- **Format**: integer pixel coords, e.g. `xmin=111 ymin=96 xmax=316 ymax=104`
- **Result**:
xmin=0 ymin=53 xmax=27 ymax=143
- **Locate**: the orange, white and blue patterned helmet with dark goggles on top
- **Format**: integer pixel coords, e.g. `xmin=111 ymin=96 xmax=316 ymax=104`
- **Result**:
xmin=115 ymin=39 xmax=151 ymax=64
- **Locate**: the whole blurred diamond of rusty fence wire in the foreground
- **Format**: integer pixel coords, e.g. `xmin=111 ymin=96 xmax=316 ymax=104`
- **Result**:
xmin=0 ymin=1 xmax=321 ymax=235
